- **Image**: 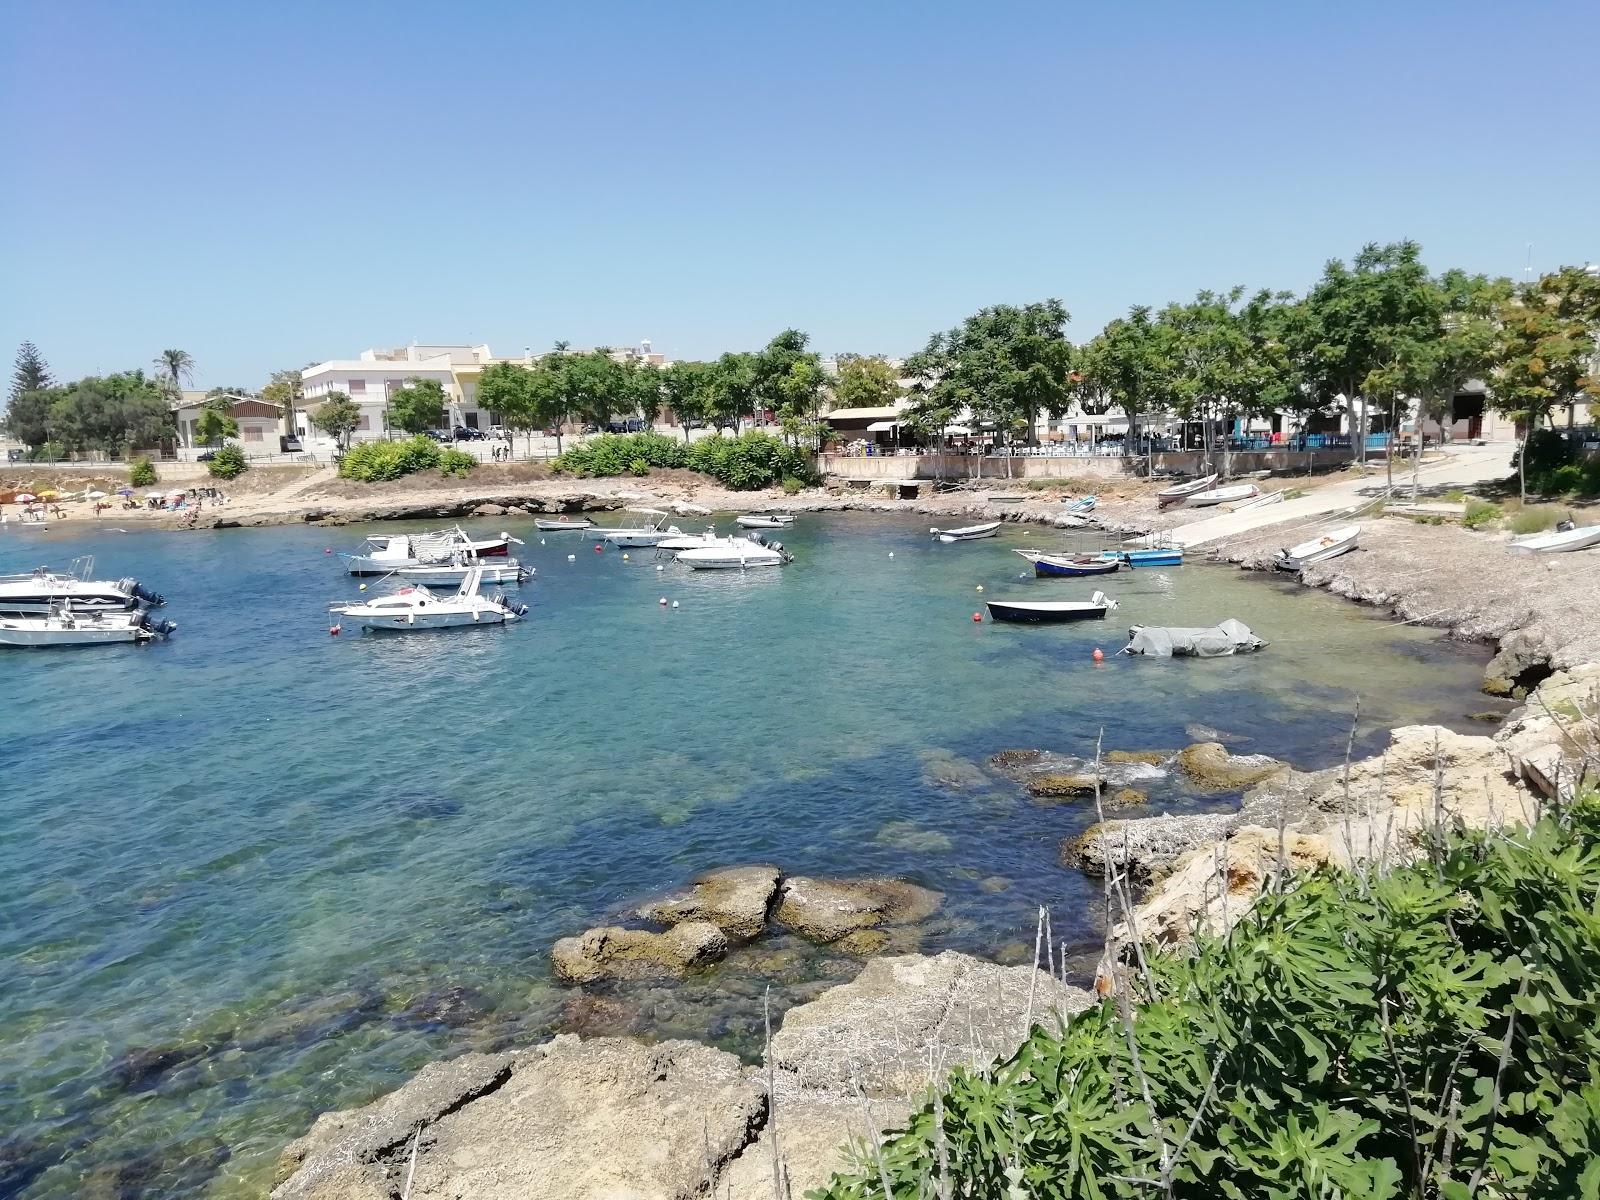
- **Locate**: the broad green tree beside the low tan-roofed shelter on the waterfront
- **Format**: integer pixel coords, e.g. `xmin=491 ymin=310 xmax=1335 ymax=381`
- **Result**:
xmin=906 ymin=299 xmax=1074 ymax=470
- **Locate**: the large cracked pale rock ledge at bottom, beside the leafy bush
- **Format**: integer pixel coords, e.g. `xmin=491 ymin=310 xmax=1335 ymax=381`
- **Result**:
xmin=272 ymin=950 xmax=1094 ymax=1200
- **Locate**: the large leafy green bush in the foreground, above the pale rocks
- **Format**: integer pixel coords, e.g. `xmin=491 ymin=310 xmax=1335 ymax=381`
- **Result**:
xmin=811 ymin=797 xmax=1600 ymax=1200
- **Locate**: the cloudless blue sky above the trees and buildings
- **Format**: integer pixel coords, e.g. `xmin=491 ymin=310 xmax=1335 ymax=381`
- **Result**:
xmin=0 ymin=0 xmax=1600 ymax=386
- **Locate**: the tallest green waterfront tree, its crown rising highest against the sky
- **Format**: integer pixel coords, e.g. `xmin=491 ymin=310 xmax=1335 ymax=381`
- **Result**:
xmin=1290 ymin=242 xmax=1434 ymax=461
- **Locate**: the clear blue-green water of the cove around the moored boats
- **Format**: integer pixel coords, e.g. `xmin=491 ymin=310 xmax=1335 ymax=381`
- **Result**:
xmin=0 ymin=515 xmax=1486 ymax=1198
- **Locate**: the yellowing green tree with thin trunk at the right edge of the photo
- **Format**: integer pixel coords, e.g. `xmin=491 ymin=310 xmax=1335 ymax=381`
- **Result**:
xmin=1490 ymin=267 xmax=1600 ymax=499
